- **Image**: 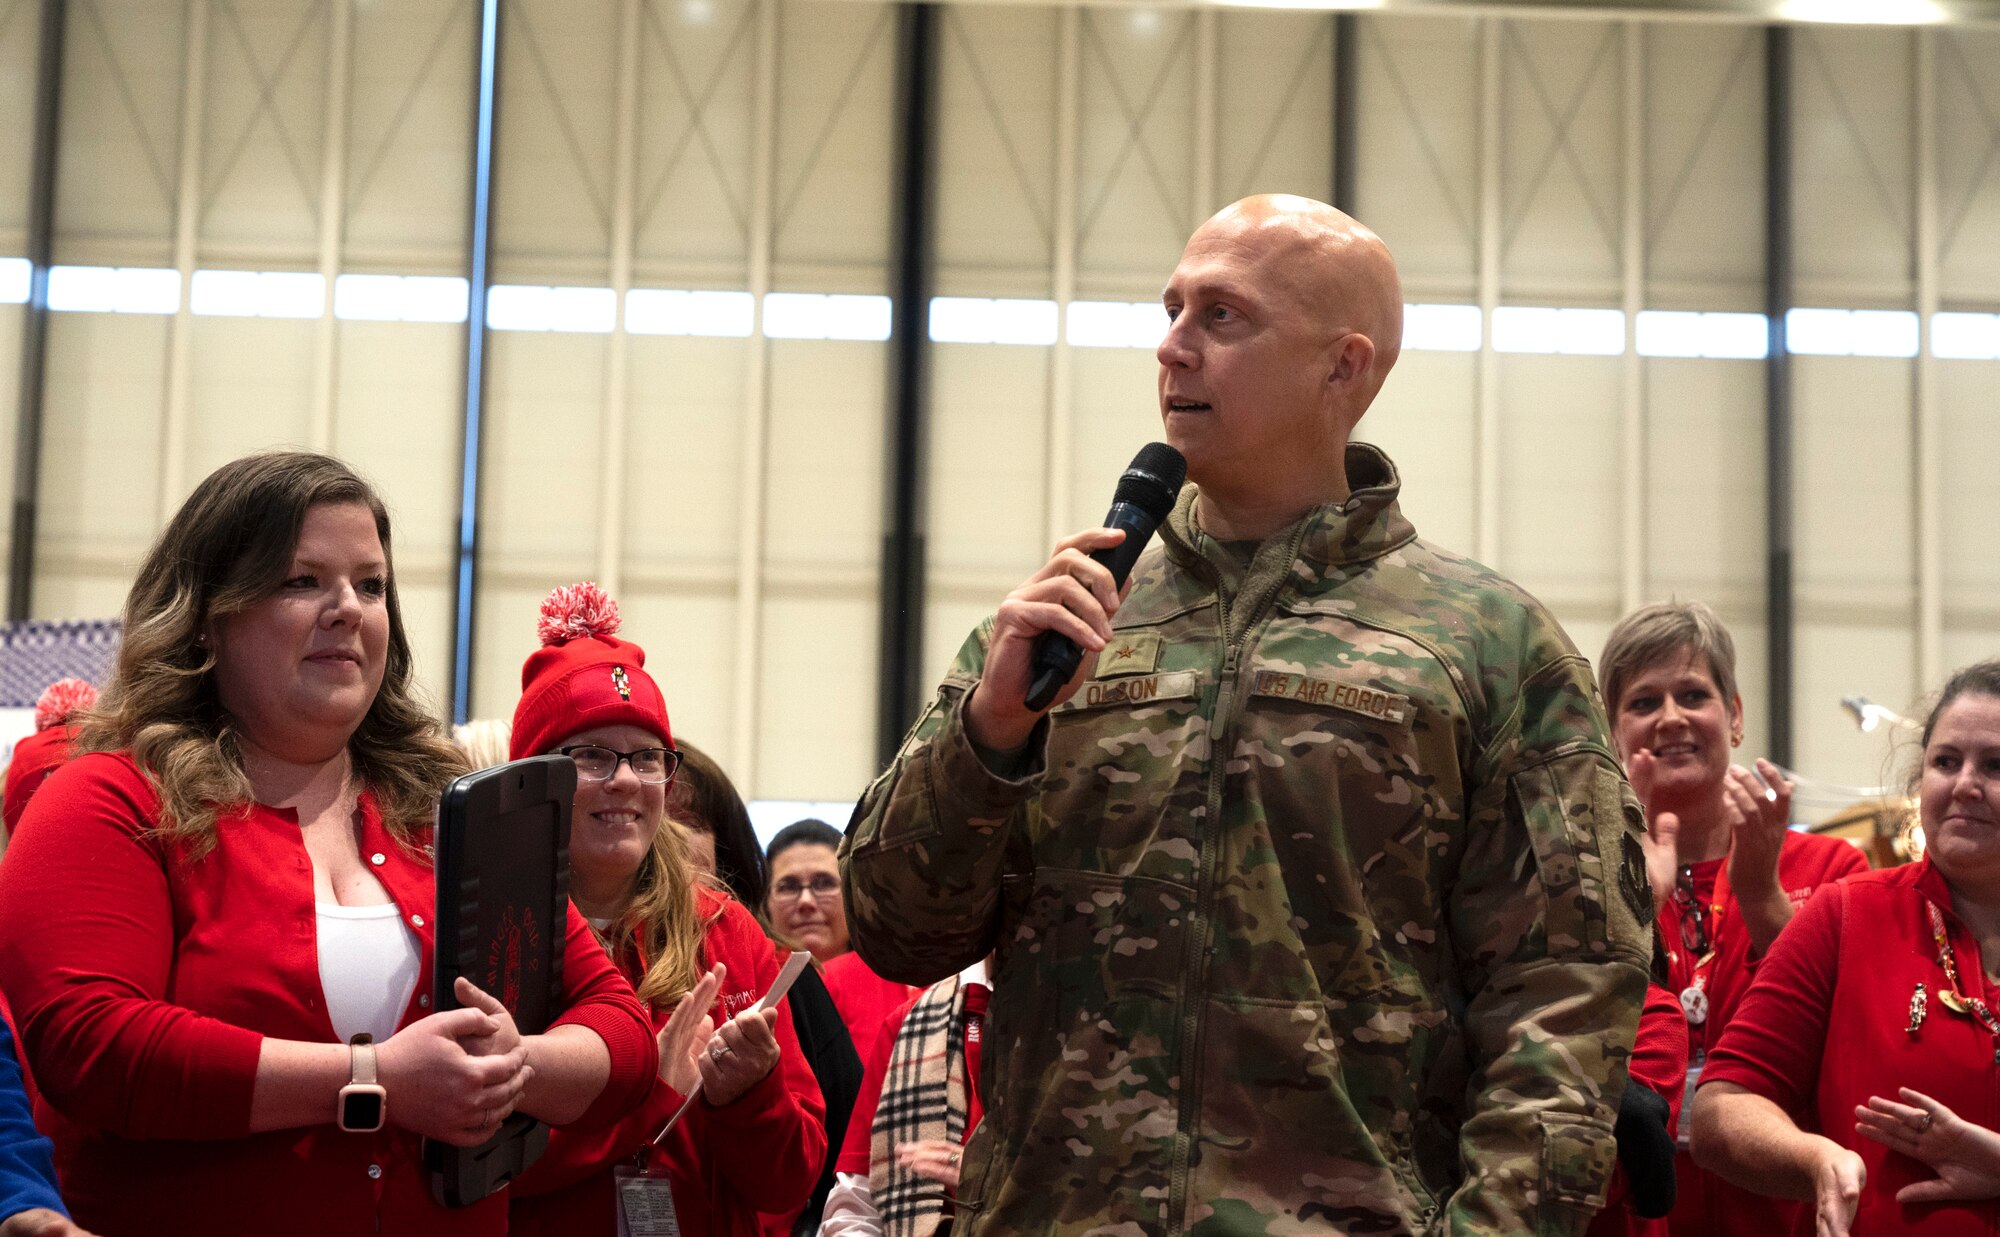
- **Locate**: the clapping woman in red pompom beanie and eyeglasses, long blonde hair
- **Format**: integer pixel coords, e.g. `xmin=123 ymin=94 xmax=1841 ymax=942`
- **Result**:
xmin=510 ymin=584 xmax=826 ymax=1237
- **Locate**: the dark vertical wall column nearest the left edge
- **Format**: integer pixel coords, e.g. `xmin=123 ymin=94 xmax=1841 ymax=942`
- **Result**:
xmin=6 ymin=0 xmax=70 ymax=621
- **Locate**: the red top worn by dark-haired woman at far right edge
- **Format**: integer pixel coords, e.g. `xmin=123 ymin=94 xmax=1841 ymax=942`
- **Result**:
xmin=1702 ymin=861 xmax=2000 ymax=1237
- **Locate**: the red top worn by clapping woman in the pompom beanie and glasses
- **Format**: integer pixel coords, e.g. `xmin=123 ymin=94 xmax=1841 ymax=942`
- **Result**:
xmin=508 ymin=889 xmax=826 ymax=1237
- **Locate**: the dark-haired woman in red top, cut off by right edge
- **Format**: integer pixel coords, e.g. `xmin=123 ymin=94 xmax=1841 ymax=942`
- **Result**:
xmin=1694 ymin=661 xmax=2000 ymax=1237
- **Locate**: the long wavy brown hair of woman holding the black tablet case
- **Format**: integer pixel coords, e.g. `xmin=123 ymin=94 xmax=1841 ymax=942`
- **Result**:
xmin=80 ymin=450 xmax=466 ymax=859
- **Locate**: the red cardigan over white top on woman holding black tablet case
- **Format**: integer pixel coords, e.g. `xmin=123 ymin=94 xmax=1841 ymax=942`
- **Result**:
xmin=0 ymin=755 xmax=658 ymax=1237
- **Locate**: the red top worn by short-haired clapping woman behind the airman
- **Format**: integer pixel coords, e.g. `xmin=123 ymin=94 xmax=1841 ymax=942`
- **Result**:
xmin=1658 ymin=831 xmax=1872 ymax=1237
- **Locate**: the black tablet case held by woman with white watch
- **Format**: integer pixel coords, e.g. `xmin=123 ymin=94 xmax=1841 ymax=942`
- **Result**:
xmin=424 ymin=757 xmax=576 ymax=1207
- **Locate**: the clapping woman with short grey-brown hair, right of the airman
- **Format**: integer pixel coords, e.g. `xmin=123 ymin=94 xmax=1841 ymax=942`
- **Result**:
xmin=1598 ymin=600 xmax=1868 ymax=1237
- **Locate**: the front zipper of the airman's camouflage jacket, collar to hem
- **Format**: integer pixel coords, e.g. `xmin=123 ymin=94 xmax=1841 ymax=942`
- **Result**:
xmin=1166 ymin=520 xmax=1312 ymax=1235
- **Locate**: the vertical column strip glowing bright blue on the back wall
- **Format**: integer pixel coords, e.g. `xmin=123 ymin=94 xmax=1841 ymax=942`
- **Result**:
xmin=452 ymin=0 xmax=500 ymax=723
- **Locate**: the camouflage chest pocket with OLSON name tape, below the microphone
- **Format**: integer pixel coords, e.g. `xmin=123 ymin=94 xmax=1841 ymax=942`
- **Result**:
xmin=1030 ymin=671 xmax=1210 ymax=881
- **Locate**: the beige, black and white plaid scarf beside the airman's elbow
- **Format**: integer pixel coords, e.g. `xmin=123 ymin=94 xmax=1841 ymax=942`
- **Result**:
xmin=868 ymin=977 xmax=966 ymax=1237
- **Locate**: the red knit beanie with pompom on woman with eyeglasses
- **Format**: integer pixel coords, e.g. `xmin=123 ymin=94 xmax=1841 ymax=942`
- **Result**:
xmin=508 ymin=580 xmax=674 ymax=761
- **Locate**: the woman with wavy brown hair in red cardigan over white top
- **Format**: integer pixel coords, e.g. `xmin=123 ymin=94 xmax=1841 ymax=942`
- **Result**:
xmin=0 ymin=454 xmax=656 ymax=1237
